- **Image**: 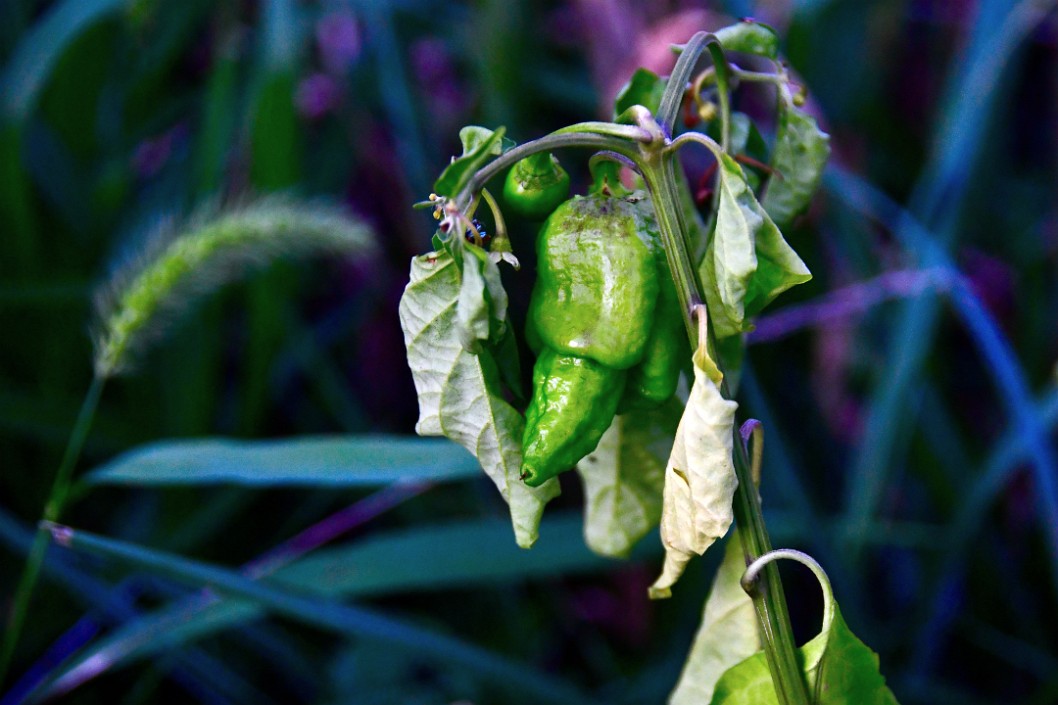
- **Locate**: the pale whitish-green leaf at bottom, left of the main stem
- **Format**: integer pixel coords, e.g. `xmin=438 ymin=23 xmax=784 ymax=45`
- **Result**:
xmin=669 ymin=529 xmax=761 ymax=705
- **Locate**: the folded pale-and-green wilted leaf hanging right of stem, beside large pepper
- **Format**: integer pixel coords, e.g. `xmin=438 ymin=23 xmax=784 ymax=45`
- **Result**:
xmin=699 ymin=155 xmax=811 ymax=338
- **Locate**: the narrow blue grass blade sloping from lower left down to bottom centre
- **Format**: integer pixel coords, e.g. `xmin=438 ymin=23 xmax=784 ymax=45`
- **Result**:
xmin=44 ymin=524 xmax=605 ymax=703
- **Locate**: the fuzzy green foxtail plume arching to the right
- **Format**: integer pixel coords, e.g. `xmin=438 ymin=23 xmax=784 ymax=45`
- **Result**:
xmin=94 ymin=196 xmax=375 ymax=378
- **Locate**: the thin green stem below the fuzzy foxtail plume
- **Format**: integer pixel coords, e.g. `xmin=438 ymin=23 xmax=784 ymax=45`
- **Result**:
xmin=0 ymin=375 xmax=107 ymax=686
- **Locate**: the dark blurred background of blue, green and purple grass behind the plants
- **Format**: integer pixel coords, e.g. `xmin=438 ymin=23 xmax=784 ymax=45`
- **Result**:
xmin=0 ymin=0 xmax=1058 ymax=705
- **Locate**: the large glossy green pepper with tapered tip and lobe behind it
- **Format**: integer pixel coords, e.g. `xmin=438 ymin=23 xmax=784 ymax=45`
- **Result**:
xmin=523 ymin=195 xmax=688 ymax=487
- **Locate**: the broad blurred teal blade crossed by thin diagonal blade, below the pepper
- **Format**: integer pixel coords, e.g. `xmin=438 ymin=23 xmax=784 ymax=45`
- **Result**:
xmin=49 ymin=512 xmax=626 ymax=694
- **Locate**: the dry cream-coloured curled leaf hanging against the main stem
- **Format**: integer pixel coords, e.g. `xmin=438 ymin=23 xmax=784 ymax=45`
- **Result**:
xmin=650 ymin=347 xmax=738 ymax=598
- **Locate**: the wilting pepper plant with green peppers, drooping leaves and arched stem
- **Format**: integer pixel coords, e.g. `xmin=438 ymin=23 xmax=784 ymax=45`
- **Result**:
xmin=400 ymin=20 xmax=896 ymax=705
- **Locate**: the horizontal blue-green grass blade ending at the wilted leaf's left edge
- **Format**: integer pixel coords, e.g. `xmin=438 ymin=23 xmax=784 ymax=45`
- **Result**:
xmin=86 ymin=436 xmax=477 ymax=487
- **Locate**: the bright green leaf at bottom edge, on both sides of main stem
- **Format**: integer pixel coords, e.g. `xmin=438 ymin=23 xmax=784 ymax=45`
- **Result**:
xmin=711 ymin=602 xmax=897 ymax=705
